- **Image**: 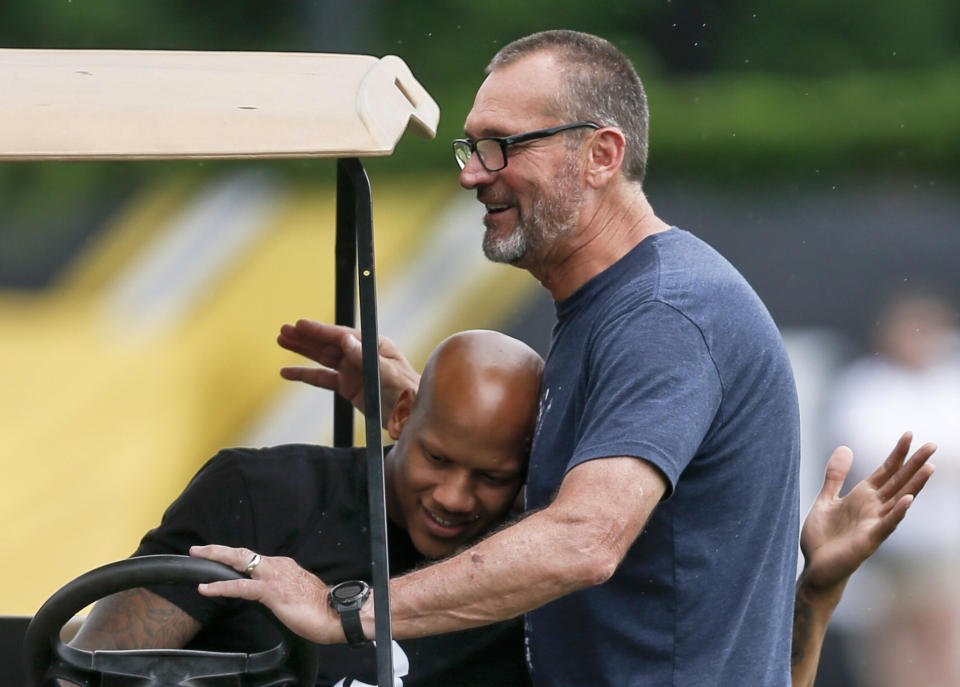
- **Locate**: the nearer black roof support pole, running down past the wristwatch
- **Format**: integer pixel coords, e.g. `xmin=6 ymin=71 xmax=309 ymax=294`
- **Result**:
xmin=337 ymin=158 xmax=393 ymax=687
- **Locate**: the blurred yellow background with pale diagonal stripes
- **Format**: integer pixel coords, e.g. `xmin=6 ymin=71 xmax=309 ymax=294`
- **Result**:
xmin=0 ymin=171 xmax=537 ymax=614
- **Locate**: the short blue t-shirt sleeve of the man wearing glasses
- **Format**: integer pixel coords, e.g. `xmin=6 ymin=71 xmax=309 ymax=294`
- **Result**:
xmin=567 ymin=301 xmax=722 ymax=495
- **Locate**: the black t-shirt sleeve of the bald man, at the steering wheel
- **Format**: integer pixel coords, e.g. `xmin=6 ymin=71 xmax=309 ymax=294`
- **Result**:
xmin=133 ymin=451 xmax=256 ymax=623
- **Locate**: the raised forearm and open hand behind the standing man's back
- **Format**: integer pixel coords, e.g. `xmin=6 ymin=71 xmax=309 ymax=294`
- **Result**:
xmin=791 ymin=432 xmax=936 ymax=687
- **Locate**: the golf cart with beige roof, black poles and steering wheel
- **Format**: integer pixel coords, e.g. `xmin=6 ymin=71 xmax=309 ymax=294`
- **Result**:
xmin=0 ymin=49 xmax=439 ymax=687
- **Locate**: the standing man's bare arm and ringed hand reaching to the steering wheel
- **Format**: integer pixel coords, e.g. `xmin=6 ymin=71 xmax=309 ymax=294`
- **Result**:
xmin=190 ymin=457 xmax=666 ymax=643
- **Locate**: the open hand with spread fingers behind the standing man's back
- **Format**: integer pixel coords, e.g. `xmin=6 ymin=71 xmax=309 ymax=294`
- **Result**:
xmin=800 ymin=432 xmax=937 ymax=593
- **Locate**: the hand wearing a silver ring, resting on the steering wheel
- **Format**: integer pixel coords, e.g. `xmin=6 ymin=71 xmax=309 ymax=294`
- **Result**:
xmin=190 ymin=544 xmax=346 ymax=644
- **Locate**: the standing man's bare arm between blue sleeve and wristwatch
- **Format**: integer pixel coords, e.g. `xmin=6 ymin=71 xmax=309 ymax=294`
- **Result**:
xmin=361 ymin=458 xmax=664 ymax=639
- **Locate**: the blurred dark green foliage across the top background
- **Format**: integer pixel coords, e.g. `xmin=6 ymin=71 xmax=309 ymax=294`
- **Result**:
xmin=0 ymin=0 xmax=960 ymax=282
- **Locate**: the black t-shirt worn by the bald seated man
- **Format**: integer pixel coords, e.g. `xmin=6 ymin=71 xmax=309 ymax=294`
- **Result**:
xmin=134 ymin=444 xmax=529 ymax=687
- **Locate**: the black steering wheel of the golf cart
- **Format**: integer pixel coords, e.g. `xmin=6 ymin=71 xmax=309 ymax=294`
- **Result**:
xmin=23 ymin=556 xmax=319 ymax=687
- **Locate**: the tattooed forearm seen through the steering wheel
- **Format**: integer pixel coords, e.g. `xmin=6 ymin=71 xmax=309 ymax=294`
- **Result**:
xmin=70 ymin=589 xmax=201 ymax=650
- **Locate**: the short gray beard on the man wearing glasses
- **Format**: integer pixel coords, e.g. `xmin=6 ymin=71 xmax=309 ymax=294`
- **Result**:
xmin=483 ymin=156 xmax=583 ymax=265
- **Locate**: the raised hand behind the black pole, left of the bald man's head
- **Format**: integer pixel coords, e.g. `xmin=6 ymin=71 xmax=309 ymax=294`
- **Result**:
xmin=277 ymin=320 xmax=420 ymax=422
